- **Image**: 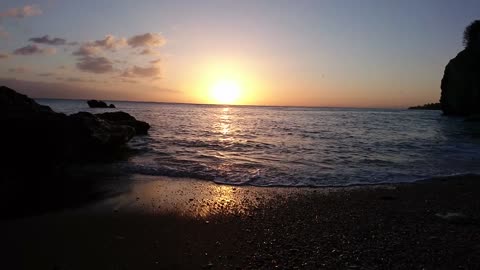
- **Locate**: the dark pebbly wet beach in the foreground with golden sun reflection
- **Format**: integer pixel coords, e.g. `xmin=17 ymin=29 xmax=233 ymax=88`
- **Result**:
xmin=0 ymin=176 xmax=480 ymax=269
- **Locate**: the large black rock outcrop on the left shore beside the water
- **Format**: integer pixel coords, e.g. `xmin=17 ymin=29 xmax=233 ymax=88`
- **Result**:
xmin=0 ymin=86 xmax=148 ymax=178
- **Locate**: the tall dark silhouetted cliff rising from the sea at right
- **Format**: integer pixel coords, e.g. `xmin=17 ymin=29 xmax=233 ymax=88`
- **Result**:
xmin=440 ymin=21 xmax=480 ymax=116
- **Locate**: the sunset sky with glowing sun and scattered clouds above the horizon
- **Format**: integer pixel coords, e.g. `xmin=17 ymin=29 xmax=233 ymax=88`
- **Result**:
xmin=0 ymin=0 xmax=480 ymax=108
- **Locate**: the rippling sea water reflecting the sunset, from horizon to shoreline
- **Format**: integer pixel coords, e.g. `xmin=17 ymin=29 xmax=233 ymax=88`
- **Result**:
xmin=37 ymin=99 xmax=480 ymax=186
